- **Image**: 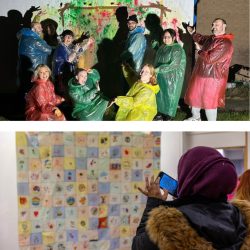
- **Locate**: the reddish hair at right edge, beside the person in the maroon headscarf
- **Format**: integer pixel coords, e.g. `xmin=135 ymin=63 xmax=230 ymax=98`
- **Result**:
xmin=233 ymin=169 xmax=250 ymax=200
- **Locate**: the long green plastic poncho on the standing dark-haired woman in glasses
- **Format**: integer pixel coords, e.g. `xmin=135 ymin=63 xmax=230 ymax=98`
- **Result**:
xmin=154 ymin=43 xmax=186 ymax=117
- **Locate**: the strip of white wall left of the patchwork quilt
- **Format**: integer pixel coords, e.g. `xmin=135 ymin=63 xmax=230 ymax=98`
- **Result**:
xmin=0 ymin=132 xmax=19 ymax=250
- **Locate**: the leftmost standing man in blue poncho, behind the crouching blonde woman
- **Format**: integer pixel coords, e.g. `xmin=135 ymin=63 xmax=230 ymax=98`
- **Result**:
xmin=17 ymin=22 xmax=51 ymax=94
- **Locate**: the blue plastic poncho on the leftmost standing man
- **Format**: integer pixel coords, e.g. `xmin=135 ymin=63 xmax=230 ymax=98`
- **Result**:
xmin=17 ymin=28 xmax=52 ymax=72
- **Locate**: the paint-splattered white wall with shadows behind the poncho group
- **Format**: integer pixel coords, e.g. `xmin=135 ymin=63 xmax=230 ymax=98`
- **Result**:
xmin=0 ymin=0 xmax=194 ymax=94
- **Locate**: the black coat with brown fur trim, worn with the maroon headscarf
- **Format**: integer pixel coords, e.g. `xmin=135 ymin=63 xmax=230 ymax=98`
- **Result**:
xmin=132 ymin=198 xmax=250 ymax=250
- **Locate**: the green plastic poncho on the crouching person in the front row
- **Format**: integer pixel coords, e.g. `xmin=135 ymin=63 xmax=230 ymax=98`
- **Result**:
xmin=68 ymin=69 xmax=108 ymax=121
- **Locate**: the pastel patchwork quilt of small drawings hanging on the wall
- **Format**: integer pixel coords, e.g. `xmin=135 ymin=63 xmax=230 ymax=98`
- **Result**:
xmin=16 ymin=132 xmax=161 ymax=250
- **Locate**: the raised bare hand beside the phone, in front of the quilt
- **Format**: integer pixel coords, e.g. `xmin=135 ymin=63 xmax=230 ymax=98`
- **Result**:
xmin=138 ymin=175 xmax=168 ymax=201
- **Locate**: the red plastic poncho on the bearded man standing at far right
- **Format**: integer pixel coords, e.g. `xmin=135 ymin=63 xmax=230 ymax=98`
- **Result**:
xmin=185 ymin=33 xmax=234 ymax=109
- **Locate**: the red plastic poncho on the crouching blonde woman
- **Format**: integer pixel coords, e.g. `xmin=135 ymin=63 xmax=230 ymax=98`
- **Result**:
xmin=25 ymin=79 xmax=66 ymax=121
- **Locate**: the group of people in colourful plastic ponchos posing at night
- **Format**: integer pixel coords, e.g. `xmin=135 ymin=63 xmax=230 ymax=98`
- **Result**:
xmin=18 ymin=7 xmax=233 ymax=121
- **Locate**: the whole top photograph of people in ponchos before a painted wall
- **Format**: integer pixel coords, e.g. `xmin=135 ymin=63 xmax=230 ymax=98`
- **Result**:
xmin=0 ymin=0 xmax=250 ymax=122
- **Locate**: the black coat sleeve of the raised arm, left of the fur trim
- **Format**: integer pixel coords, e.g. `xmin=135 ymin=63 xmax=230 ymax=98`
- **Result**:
xmin=132 ymin=197 xmax=162 ymax=250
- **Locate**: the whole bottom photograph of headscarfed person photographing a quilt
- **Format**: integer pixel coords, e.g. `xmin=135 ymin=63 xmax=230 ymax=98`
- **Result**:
xmin=0 ymin=131 xmax=250 ymax=250
